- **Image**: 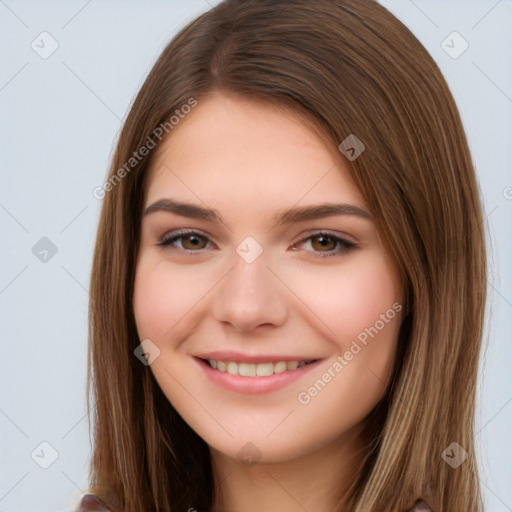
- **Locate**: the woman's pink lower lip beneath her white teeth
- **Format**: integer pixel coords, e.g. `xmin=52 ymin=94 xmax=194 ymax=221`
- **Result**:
xmin=194 ymin=357 xmax=322 ymax=395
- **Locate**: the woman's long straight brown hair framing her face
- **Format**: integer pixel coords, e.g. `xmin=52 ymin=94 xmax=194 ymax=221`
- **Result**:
xmin=87 ymin=0 xmax=486 ymax=512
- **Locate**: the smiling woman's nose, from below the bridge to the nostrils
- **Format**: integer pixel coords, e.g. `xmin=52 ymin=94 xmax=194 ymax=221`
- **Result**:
xmin=213 ymin=247 xmax=288 ymax=331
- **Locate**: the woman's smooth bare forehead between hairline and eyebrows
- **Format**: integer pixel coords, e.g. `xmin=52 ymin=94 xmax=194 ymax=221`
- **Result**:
xmin=145 ymin=94 xmax=364 ymax=208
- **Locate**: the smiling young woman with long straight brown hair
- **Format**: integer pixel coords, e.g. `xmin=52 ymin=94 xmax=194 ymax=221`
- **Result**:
xmin=77 ymin=0 xmax=486 ymax=512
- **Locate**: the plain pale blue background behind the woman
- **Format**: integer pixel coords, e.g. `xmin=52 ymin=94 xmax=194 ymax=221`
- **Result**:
xmin=0 ymin=0 xmax=512 ymax=512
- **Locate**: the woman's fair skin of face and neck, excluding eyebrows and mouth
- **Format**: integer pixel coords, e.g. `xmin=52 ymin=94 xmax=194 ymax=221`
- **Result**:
xmin=133 ymin=93 xmax=402 ymax=512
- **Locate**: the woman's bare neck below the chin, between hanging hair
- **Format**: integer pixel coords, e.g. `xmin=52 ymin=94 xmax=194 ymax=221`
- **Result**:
xmin=210 ymin=432 xmax=364 ymax=512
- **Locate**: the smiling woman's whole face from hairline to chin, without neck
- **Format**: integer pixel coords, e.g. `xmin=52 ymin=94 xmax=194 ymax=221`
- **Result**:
xmin=133 ymin=94 xmax=402 ymax=462
